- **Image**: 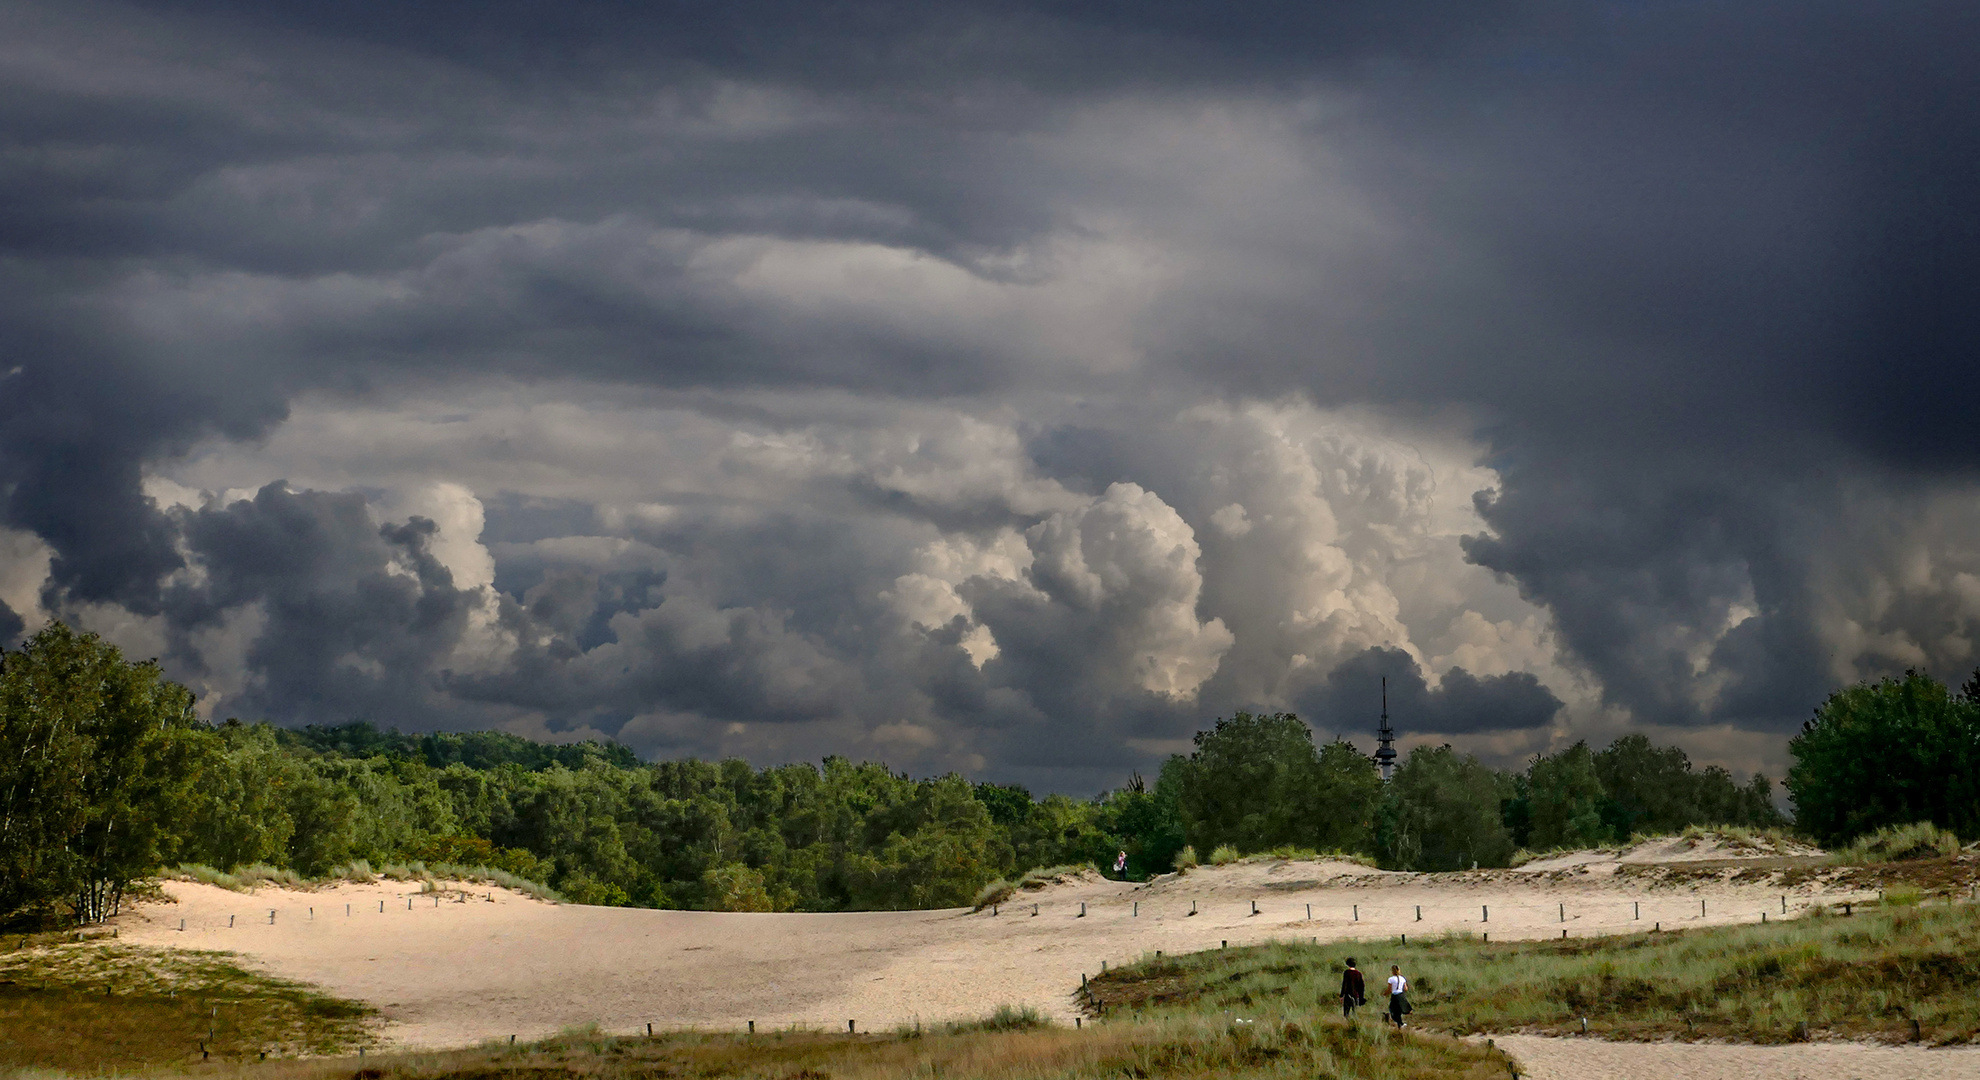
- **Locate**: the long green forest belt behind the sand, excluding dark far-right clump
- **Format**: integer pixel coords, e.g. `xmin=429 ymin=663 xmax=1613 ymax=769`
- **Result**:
xmin=0 ymin=624 xmax=1980 ymax=921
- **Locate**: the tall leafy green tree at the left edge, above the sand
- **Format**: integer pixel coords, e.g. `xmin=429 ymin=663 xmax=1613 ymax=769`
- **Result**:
xmin=0 ymin=622 xmax=212 ymax=921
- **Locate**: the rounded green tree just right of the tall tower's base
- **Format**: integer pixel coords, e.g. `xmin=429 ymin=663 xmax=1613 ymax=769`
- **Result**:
xmin=1376 ymin=743 xmax=1513 ymax=870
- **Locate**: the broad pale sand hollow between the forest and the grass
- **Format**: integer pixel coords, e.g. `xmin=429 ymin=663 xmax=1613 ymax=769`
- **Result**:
xmin=119 ymin=840 xmax=1865 ymax=1046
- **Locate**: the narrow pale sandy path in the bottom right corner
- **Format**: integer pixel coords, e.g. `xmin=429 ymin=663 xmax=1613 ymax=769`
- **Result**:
xmin=1497 ymin=1034 xmax=1980 ymax=1080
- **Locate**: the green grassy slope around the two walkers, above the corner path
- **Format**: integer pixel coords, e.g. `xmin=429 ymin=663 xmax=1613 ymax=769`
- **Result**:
xmin=1089 ymin=891 xmax=1980 ymax=1044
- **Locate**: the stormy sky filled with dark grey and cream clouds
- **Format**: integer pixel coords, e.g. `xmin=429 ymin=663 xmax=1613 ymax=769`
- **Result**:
xmin=0 ymin=0 xmax=1980 ymax=793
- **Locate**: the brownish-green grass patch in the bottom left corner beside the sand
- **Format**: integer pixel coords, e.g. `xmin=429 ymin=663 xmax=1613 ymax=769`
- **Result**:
xmin=0 ymin=937 xmax=374 ymax=1074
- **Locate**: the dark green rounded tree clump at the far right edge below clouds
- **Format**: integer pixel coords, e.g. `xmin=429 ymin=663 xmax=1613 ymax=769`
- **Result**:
xmin=1788 ymin=672 xmax=1980 ymax=844
